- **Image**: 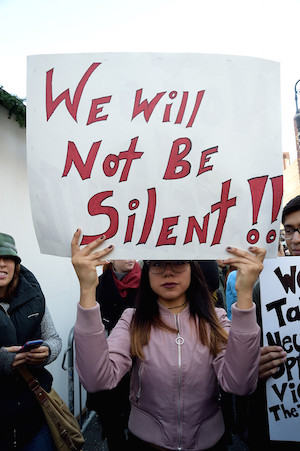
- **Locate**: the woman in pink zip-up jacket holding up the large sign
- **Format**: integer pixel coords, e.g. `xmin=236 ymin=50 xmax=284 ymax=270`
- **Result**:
xmin=72 ymin=230 xmax=265 ymax=451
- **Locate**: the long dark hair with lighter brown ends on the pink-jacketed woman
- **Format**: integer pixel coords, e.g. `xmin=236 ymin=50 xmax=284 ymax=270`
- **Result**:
xmin=131 ymin=261 xmax=228 ymax=359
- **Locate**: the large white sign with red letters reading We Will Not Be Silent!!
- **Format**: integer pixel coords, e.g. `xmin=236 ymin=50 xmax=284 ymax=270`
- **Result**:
xmin=27 ymin=53 xmax=283 ymax=259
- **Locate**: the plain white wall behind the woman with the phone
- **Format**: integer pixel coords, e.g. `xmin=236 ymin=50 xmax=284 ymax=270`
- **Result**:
xmin=0 ymin=106 xmax=79 ymax=413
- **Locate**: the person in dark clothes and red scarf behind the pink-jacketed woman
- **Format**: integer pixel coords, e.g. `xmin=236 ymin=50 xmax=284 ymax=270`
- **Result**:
xmin=87 ymin=260 xmax=141 ymax=451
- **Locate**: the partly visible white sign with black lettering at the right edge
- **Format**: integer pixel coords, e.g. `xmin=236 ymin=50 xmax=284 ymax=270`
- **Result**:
xmin=260 ymin=257 xmax=300 ymax=442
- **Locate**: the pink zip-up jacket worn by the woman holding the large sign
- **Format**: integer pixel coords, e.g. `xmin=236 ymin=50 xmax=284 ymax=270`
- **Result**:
xmin=74 ymin=304 xmax=260 ymax=451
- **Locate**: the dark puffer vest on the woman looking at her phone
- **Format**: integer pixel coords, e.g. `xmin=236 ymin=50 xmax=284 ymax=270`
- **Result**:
xmin=0 ymin=266 xmax=52 ymax=450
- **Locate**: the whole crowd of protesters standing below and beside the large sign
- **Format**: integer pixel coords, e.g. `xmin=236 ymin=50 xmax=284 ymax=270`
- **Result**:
xmin=0 ymin=196 xmax=300 ymax=451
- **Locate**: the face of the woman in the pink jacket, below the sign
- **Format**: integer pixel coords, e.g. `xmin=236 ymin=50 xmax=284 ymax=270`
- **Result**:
xmin=149 ymin=263 xmax=191 ymax=307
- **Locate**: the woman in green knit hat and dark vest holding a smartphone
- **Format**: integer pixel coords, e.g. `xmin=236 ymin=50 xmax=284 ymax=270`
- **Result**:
xmin=0 ymin=233 xmax=61 ymax=451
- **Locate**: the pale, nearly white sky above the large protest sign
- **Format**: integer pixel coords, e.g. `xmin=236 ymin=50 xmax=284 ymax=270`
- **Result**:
xmin=0 ymin=0 xmax=300 ymax=160
